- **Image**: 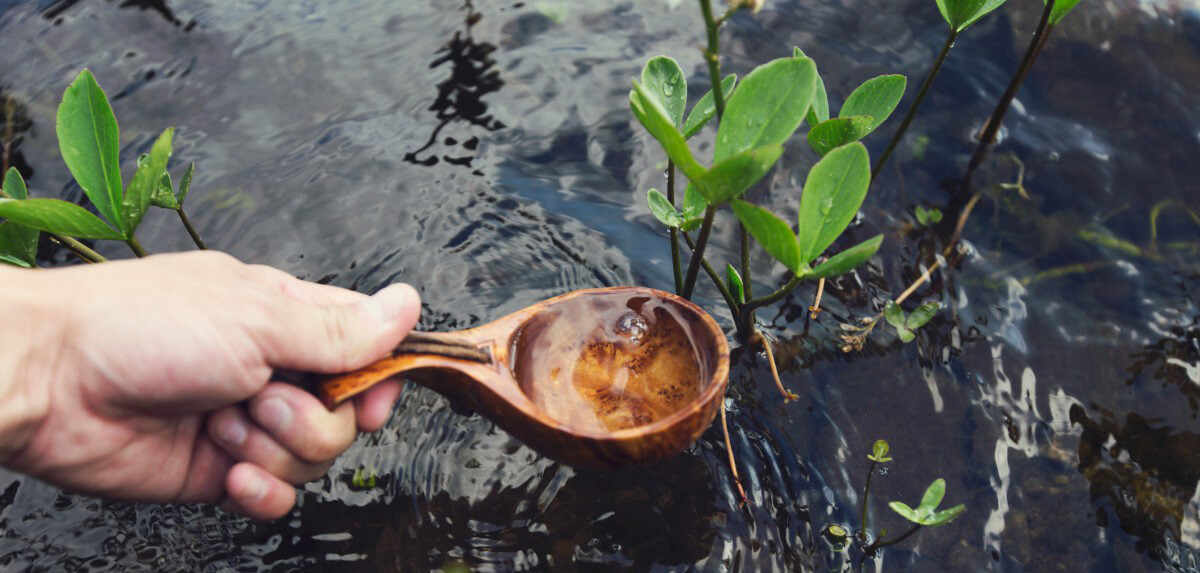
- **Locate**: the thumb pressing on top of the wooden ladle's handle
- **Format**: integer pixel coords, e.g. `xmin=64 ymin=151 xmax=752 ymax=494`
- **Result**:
xmin=259 ymin=283 xmax=421 ymax=374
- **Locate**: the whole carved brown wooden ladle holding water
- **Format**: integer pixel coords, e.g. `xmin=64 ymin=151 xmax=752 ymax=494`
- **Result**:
xmin=318 ymin=287 xmax=730 ymax=468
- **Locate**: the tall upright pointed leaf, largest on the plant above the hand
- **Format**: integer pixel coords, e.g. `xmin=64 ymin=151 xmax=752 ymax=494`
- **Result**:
xmin=54 ymin=70 xmax=122 ymax=224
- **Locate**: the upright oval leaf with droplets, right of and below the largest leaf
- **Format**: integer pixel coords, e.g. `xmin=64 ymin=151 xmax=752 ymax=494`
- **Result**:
xmin=798 ymin=143 xmax=871 ymax=263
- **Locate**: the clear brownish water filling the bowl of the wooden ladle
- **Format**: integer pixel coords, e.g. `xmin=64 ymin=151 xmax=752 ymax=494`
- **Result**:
xmin=512 ymin=295 xmax=703 ymax=432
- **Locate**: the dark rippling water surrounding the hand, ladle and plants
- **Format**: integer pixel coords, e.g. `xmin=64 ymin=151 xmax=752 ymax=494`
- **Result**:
xmin=0 ymin=0 xmax=1200 ymax=572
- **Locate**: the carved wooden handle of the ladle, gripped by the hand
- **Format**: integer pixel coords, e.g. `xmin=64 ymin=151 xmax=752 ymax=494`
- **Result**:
xmin=271 ymin=331 xmax=493 ymax=409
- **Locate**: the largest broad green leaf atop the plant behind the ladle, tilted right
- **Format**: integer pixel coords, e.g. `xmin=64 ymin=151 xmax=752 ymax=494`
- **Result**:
xmin=715 ymin=58 xmax=817 ymax=161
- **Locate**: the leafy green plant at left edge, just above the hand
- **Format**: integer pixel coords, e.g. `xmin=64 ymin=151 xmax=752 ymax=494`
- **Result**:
xmin=0 ymin=70 xmax=206 ymax=267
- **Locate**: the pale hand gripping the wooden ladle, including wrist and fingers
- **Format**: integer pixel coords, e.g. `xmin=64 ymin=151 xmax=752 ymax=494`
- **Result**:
xmin=0 ymin=252 xmax=420 ymax=520
